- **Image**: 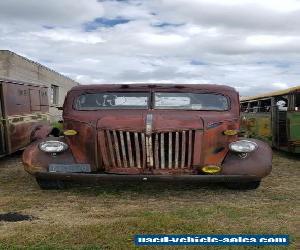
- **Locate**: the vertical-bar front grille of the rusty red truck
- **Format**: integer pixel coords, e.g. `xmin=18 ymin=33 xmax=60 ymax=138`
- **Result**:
xmin=104 ymin=130 xmax=195 ymax=169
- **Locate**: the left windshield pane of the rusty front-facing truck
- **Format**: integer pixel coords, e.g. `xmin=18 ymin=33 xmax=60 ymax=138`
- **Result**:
xmin=75 ymin=92 xmax=149 ymax=110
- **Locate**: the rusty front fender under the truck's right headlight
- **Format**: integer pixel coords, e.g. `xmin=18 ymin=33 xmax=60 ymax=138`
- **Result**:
xmin=221 ymin=138 xmax=272 ymax=178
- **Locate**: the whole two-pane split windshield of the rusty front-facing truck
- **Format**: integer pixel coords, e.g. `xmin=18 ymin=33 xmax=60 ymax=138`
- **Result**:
xmin=75 ymin=92 xmax=229 ymax=111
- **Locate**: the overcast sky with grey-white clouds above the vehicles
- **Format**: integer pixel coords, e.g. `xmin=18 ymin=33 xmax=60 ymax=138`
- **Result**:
xmin=0 ymin=0 xmax=300 ymax=95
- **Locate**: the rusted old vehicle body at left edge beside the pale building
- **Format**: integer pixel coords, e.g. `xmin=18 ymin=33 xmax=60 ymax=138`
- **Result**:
xmin=0 ymin=79 xmax=51 ymax=156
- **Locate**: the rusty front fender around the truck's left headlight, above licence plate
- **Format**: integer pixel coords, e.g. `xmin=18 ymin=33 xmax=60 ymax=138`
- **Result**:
xmin=22 ymin=137 xmax=76 ymax=175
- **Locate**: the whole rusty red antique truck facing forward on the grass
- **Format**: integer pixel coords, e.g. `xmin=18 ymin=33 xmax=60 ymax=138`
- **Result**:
xmin=23 ymin=84 xmax=272 ymax=189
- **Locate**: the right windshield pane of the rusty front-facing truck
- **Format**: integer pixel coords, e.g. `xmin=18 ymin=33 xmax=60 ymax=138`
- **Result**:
xmin=154 ymin=92 xmax=229 ymax=111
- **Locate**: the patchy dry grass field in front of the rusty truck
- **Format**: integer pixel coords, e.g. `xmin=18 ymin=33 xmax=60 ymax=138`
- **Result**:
xmin=0 ymin=153 xmax=300 ymax=249
